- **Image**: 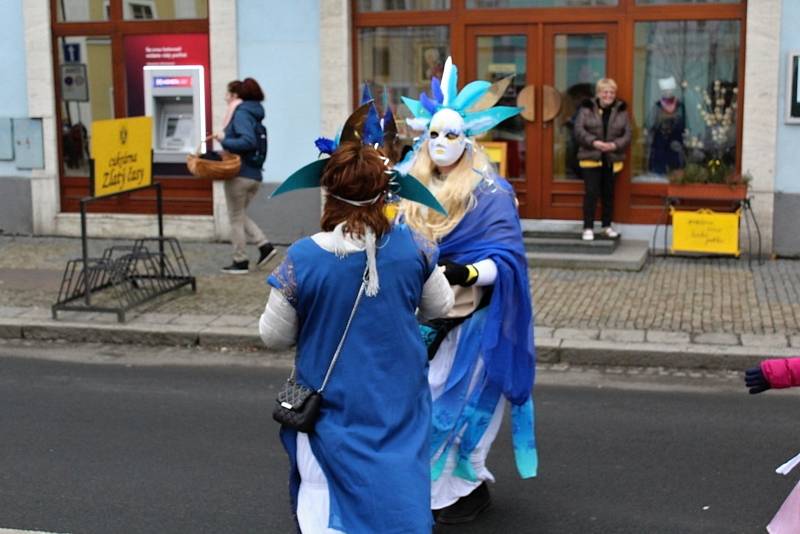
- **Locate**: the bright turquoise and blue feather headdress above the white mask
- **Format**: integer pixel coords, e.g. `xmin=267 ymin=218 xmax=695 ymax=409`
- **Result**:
xmin=402 ymin=57 xmax=522 ymax=137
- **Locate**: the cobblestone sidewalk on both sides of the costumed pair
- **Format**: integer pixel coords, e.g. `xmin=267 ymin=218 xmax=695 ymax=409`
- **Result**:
xmin=0 ymin=236 xmax=800 ymax=336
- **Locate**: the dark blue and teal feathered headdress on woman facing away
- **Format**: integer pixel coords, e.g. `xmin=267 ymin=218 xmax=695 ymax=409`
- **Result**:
xmin=271 ymin=84 xmax=447 ymax=215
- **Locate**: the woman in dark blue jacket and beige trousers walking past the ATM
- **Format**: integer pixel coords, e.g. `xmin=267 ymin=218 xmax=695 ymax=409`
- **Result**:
xmin=214 ymin=78 xmax=277 ymax=274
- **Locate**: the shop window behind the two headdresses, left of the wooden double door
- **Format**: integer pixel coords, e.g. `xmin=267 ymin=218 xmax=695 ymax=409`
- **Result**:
xmin=358 ymin=26 xmax=450 ymax=139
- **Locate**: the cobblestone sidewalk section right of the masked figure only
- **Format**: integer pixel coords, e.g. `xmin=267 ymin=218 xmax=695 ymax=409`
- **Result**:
xmin=531 ymin=258 xmax=800 ymax=335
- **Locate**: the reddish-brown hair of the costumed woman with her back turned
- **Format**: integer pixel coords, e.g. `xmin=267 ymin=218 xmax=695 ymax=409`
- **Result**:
xmin=320 ymin=142 xmax=390 ymax=241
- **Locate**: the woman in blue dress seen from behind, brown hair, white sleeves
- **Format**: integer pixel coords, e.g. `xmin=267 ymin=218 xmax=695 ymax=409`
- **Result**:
xmin=260 ymin=142 xmax=453 ymax=534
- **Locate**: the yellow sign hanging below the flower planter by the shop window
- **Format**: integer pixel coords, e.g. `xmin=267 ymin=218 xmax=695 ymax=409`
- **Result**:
xmin=670 ymin=208 xmax=741 ymax=256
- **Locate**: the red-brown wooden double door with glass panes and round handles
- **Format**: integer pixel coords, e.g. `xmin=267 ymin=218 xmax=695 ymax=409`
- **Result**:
xmin=461 ymin=23 xmax=616 ymax=220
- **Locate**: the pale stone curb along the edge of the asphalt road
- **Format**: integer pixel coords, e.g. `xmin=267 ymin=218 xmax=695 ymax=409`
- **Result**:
xmin=0 ymin=317 xmax=800 ymax=370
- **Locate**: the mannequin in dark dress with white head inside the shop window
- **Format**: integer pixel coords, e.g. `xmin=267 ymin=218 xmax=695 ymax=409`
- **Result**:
xmin=646 ymin=76 xmax=686 ymax=175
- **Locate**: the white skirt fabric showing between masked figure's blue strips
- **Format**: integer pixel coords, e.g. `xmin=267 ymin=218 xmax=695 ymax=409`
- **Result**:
xmin=428 ymin=327 xmax=505 ymax=510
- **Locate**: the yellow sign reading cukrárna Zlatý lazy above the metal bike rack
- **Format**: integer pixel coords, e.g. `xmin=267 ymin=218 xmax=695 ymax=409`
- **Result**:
xmin=92 ymin=117 xmax=153 ymax=197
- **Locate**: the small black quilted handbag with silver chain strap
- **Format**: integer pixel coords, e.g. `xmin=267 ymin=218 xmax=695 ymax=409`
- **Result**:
xmin=272 ymin=269 xmax=368 ymax=433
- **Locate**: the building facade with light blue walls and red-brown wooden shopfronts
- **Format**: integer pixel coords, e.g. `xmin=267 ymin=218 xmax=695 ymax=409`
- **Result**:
xmin=0 ymin=0 xmax=800 ymax=256
